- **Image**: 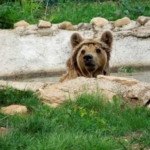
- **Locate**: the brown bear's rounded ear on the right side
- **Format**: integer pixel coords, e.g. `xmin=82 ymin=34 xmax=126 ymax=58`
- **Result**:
xmin=100 ymin=31 xmax=113 ymax=47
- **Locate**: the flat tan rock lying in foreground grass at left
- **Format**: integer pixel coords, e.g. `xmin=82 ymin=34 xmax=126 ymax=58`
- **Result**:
xmin=1 ymin=105 xmax=28 ymax=115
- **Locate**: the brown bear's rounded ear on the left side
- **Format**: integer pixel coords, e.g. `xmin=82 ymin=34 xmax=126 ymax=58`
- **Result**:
xmin=70 ymin=33 xmax=83 ymax=48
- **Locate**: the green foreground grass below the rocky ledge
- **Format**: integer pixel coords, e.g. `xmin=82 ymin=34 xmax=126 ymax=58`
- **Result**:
xmin=0 ymin=88 xmax=150 ymax=150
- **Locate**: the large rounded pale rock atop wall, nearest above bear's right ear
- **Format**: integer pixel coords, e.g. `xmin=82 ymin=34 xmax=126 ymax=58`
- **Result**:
xmin=90 ymin=17 xmax=108 ymax=27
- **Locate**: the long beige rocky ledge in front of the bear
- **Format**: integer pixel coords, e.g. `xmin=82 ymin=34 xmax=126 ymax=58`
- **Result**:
xmin=0 ymin=75 xmax=150 ymax=108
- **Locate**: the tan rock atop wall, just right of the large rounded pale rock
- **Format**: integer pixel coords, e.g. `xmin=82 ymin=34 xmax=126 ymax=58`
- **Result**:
xmin=114 ymin=17 xmax=131 ymax=27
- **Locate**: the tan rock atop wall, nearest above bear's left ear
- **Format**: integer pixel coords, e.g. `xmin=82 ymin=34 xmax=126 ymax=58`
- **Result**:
xmin=58 ymin=21 xmax=75 ymax=30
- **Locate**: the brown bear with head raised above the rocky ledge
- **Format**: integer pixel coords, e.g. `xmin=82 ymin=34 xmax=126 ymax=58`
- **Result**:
xmin=59 ymin=31 xmax=113 ymax=82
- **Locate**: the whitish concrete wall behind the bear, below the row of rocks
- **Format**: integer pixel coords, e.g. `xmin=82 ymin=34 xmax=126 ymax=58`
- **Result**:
xmin=0 ymin=25 xmax=150 ymax=77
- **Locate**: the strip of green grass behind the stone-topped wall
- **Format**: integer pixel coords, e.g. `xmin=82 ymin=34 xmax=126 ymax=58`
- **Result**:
xmin=0 ymin=0 xmax=150 ymax=28
